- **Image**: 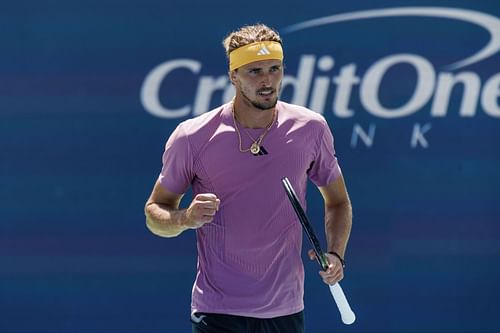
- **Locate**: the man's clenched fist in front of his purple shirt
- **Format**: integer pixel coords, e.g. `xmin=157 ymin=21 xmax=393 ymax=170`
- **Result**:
xmin=185 ymin=193 xmax=220 ymax=229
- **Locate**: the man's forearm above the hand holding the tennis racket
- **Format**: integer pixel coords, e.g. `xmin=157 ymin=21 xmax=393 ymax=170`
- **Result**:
xmin=325 ymin=200 xmax=352 ymax=258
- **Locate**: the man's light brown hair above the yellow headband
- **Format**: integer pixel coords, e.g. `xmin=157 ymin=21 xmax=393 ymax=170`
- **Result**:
xmin=222 ymin=23 xmax=283 ymax=58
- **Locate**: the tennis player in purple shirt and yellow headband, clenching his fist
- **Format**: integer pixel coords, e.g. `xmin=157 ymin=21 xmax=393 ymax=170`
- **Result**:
xmin=145 ymin=24 xmax=352 ymax=333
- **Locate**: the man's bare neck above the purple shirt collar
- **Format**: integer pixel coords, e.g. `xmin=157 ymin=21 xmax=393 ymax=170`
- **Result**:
xmin=233 ymin=97 xmax=276 ymax=128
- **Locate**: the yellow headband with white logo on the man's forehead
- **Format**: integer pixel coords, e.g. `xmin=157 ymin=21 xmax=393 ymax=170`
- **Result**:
xmin=229 ymin=41 xmax=283 ymax=71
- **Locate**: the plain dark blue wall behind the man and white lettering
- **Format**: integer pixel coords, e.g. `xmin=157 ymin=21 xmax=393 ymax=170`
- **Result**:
xmin=0 ymin=0 xmax=500 ymax=333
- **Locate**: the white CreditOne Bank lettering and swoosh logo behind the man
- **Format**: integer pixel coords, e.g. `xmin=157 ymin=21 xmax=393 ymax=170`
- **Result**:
xmin=141 ymin=7 xmax=500 ymax=148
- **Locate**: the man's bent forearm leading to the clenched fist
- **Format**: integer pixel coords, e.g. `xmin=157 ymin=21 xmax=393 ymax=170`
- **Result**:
xmin=144 ymin=203 xmax=188 ymax=237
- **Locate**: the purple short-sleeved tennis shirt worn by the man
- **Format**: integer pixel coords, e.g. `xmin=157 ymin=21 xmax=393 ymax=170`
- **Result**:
xmin=159 ymin=102 xmax=341 ymax=318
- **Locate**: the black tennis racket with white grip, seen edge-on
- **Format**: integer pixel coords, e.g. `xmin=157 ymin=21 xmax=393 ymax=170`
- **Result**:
xmin=281 ymin=177 xmax=356 ymax=325
